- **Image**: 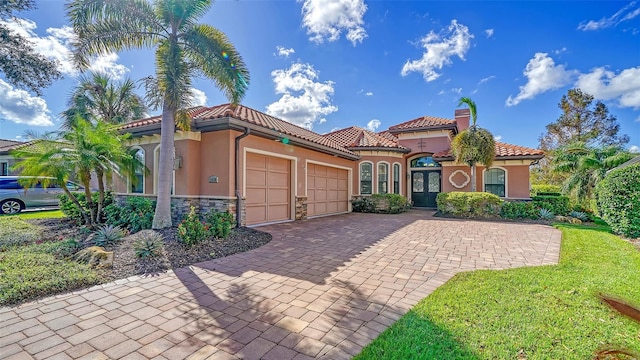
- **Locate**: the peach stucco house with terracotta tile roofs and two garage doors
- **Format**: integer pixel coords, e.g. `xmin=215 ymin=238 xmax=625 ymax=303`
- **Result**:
xmin=115 ymin=104 xmax=544 ymax=225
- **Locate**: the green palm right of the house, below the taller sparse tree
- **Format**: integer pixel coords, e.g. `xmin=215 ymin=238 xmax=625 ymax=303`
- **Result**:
xmin=552 ymin=142 xmax=633 ymax=204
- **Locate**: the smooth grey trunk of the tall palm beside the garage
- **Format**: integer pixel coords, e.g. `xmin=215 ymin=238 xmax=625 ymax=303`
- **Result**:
xmin=152 ymin=102 xmax=176 ymax=229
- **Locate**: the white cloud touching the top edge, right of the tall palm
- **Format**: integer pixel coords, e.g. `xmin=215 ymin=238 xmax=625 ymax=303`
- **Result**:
xmin=298 ymin=0 xmax=368 ymax=46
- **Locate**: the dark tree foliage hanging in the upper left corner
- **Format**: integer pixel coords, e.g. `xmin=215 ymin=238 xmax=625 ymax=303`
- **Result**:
xmin=0 ymin=0 xmax=60 ymax=95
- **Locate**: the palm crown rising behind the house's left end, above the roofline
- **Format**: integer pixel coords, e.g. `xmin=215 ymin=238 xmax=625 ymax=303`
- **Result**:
xmin=62 ymin=72 xmax=147 ymax=128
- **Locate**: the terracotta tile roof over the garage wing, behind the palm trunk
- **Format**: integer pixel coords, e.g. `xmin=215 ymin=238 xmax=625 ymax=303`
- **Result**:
xmin=121 ymin=104 xmax=355 ymax=156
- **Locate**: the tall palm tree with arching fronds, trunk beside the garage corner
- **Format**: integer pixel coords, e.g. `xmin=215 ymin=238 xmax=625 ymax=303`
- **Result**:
xmin=67 ymin=0 xmax=249 ymax=229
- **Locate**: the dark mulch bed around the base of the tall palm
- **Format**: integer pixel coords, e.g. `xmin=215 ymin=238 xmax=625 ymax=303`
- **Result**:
xmin=28 ymin=219 xmax=271 ymax=281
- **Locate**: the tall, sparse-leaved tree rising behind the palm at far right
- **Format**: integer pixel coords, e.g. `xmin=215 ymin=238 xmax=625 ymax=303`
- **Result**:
xmin=540 ymin=89 xmax=629 ymax=151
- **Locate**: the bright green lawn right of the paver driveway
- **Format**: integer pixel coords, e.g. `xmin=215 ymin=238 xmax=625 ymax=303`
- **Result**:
xmin=356 ymin=225 xmax=640 ymax=360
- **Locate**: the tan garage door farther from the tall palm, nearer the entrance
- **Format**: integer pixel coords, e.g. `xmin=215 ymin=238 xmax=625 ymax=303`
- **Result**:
xmin=307 ymin=164 xmax=349 ymax=216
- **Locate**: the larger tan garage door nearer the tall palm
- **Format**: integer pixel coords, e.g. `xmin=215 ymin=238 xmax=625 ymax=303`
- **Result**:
xmin=245 ymin=153 xmax=291 ymax=225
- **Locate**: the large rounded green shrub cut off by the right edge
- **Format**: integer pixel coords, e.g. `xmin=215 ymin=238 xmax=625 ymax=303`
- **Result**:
xmin=596 ymin=164 xmax=640 ymax=238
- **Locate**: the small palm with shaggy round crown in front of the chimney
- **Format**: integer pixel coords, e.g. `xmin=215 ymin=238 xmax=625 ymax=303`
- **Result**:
xmin=451 ymin=97 xmax=496 ymax=191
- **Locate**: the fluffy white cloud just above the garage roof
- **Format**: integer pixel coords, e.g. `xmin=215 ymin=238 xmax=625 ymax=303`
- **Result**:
xmin=267 ymin=63 xmax=338 ymax=129
